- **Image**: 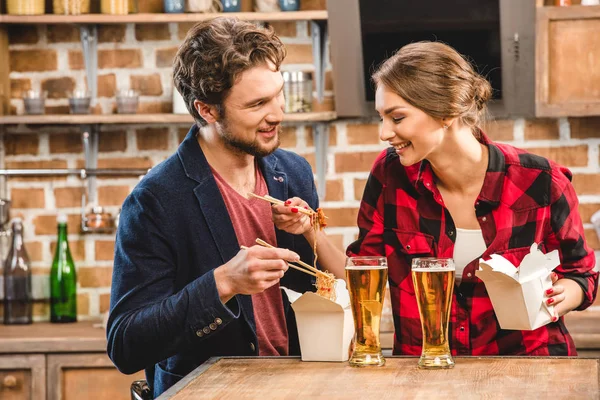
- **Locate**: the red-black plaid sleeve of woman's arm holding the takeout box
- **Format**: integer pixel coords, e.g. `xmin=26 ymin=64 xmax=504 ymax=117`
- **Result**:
xmin=546 ymin=167 xmax=598 ymax=310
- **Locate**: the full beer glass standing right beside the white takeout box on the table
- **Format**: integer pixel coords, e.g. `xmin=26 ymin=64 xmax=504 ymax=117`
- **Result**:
xmin=346 ymin=257 xmax=387 ymax=367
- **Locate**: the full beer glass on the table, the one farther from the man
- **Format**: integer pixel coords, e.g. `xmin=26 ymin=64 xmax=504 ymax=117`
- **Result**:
xmin=412 ymin=258 xmax=455 ymax=369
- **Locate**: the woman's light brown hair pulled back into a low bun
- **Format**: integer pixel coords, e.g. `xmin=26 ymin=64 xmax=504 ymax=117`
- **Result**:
xmin=373 ymin=42 xmax=492 ymax=134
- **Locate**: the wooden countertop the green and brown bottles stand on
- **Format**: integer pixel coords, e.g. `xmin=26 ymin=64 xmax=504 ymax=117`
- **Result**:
xmin=0 ymin=322 xmax=106 ymax=354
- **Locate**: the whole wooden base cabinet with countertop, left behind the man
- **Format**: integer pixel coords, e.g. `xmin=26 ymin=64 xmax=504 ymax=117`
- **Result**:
xmin=0 ymin=322 xmax=144 ymax=400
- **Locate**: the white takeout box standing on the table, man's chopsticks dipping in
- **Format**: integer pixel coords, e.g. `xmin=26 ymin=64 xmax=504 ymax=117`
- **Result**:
xmin=282 ymin=279 xmax=354 ymax=361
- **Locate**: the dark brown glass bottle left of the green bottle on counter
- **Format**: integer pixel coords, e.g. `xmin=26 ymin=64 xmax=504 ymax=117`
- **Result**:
xmin=4 ymin=218 xmax=33 ymax=325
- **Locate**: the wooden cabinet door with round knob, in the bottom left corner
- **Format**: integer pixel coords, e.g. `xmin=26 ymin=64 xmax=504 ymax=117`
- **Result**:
xmin=0 ymin=354 xmax=46 ymax=400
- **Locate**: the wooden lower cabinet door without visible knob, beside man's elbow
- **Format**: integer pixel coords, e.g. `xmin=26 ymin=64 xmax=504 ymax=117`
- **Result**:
xmin=48 ymin=353 xmax=145 ymax=400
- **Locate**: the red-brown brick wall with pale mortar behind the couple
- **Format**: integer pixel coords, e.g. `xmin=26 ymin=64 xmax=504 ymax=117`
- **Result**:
xmin=3 ymin=7 xmax=600 ymax=320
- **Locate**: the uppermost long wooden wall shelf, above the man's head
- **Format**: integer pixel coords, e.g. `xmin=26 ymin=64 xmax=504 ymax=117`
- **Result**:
xmin=0 ymin=10 xmax=327 ymax=24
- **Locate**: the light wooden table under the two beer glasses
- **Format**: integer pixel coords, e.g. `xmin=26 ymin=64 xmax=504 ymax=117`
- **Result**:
xmin=158 ymin=357 xmax=600 ymax=400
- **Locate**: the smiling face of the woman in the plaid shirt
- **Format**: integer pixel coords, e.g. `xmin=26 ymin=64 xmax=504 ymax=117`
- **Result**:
xmin=375 ymin=84 xmax=444 ymax=166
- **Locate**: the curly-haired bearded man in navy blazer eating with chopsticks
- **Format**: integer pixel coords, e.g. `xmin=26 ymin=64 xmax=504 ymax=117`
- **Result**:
xmin=107 ymin=18 xmax=318 ymax=396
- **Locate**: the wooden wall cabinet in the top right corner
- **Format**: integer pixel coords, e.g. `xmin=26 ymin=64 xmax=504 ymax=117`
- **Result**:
xmin=536 ymin=6 xmax=600 ymax=117
